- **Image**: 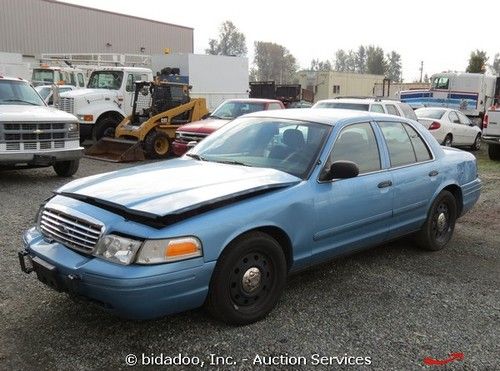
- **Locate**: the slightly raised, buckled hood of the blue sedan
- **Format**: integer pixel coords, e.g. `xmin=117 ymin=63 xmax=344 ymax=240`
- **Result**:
xmin=55 ymin=158 xmax=301 ymax=224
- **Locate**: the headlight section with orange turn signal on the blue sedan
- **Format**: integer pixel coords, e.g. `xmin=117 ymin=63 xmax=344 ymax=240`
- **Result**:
xmin=136 ymin=237 xmax=203 ymax=264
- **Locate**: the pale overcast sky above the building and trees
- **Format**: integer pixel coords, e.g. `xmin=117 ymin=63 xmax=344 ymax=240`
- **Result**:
xmin=60 ymin=0 xmax=500 ymax=82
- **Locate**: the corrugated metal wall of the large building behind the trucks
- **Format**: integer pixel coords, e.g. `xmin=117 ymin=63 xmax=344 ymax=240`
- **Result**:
xmin=0 ymin=0 xmax=193 ymax=55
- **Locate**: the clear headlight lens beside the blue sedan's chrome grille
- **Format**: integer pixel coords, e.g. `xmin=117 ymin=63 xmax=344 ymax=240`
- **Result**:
xmin=94 ymin=234 xmax=142 ymax=264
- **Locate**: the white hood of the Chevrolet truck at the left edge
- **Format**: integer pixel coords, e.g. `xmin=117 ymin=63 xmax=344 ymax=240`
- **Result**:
xmin=0 ymin=104 xmax=77 ymax=122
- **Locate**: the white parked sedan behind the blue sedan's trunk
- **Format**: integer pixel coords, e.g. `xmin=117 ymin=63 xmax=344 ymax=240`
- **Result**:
xmin=415 ymin=107 xmax=481 ymax=150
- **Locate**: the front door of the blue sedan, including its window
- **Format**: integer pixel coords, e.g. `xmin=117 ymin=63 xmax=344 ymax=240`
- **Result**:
xmin=312 ymin=122 xmax=393 ymax=262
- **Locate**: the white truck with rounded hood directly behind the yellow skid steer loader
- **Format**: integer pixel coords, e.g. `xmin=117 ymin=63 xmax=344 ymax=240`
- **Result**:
xmin=58 ymin=67 xmax=153 ymax=140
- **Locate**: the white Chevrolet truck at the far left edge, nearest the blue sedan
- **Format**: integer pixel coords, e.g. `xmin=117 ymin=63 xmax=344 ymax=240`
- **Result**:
xmin=0 ymin=75 xmax=83 ymax=177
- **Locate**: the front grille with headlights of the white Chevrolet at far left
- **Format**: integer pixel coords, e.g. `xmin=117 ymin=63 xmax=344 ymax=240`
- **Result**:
xmin=0 ymin=122 xmax=79 ymax=151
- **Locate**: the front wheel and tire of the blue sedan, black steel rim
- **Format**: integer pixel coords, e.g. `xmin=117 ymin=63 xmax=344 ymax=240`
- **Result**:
xmin=206 ymin=232 xmax=287 ymax=325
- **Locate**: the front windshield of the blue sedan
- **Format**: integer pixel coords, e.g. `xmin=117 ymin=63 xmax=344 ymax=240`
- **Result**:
xmin=188 ymin=117 xmax=331 ymax=179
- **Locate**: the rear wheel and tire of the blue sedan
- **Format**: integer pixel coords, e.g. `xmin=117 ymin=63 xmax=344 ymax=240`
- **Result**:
xmin=416 ymin=191 xmax=457 ymax=251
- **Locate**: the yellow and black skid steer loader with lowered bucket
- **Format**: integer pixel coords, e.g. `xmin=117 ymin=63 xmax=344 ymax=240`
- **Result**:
xmin=85 ymin=81 xmax=208 ymax=162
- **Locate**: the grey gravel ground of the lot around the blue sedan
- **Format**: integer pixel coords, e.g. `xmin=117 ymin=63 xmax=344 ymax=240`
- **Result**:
xmin=0 ymin=149 xmax=500 ymax=370
